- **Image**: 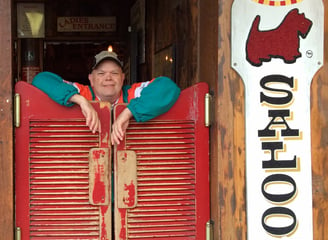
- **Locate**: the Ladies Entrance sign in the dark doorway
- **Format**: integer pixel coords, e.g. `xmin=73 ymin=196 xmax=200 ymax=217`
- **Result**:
xmin=57 ymin=16 xmax=116 ymax=32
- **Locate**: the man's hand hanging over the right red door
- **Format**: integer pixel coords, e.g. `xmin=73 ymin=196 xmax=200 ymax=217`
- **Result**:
xmin=111 ymin=108 xmax=133 ymax=145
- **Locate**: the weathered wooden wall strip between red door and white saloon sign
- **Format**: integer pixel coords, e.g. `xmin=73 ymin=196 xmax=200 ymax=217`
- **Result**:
xmin=211 ymin=0 xmax=246 ymax=240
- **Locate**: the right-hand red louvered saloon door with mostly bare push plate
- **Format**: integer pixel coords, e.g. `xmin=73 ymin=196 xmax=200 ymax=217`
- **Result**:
xmin=114 ymin=83 xmax=210 ymax=240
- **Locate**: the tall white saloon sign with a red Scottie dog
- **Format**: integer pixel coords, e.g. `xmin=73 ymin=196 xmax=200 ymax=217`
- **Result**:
xmin=231 ymin=0 xmax=324 ymax=240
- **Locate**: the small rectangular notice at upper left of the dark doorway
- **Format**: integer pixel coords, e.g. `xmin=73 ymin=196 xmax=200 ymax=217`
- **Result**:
xmin=17 ymin=3 xmax=44 ymax=38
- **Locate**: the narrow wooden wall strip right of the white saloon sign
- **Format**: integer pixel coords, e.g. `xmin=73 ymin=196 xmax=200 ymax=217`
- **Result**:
xmin=311 ymin=0 xmax=328 ymax=240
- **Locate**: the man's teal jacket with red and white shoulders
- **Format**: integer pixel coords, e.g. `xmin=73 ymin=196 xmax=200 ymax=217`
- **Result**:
xmin=32 ymin=72 xmax=180 ymax=122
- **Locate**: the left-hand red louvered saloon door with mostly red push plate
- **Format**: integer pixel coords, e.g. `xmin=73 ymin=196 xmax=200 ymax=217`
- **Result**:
xmin=15 ymin=82 xmax=112 ymax=240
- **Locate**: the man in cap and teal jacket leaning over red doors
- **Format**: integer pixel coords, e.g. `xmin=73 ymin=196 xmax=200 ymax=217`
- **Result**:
xmin=32 ymin=51 xmax=180 ymax=145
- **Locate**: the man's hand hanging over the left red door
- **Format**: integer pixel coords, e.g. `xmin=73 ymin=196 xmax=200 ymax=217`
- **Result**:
xmin=69 ymin=94 xmax=101 ymax=133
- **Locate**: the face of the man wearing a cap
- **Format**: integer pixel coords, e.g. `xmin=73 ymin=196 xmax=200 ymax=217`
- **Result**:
xmin=89 ymin=60 xmax=125 ymax=104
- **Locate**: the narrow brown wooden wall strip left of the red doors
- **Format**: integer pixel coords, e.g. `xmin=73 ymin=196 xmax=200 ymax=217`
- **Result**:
xmin=0 ymin=0 xmax=14 ymax=240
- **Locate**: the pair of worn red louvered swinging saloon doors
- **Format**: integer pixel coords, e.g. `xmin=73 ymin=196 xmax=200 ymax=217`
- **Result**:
xmin=15 ymin=82 xmax=209 ymax=240
